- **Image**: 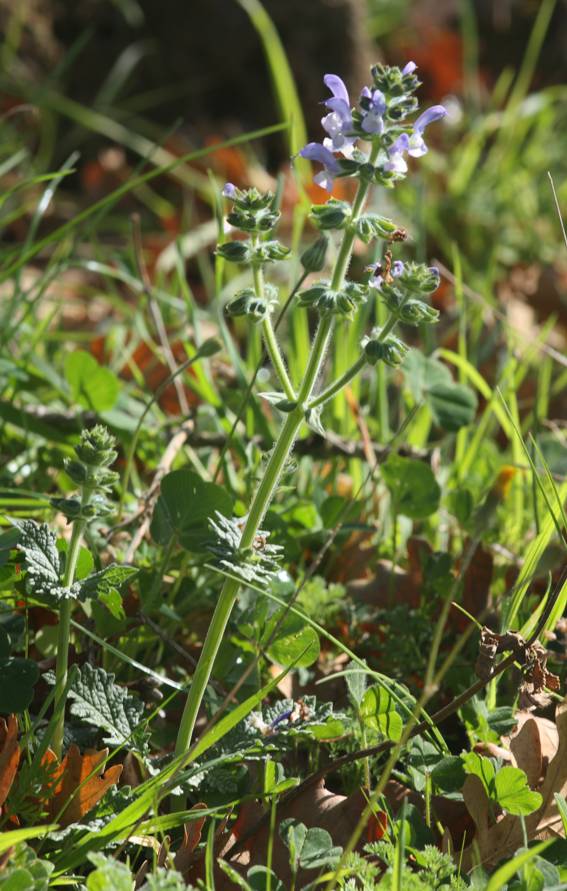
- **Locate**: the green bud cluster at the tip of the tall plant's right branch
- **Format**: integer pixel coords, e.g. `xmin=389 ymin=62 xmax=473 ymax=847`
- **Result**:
xmin=369 ymin=260 xmax=439 ymax=325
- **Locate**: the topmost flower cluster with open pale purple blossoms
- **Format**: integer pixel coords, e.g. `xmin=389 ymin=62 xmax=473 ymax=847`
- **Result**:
xmin=299 ymin=62 xmax=447 ymax=193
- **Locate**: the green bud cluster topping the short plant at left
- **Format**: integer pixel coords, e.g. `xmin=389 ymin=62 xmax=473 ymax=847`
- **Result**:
xmin=51 ymin=424 xmax=118 ymax=521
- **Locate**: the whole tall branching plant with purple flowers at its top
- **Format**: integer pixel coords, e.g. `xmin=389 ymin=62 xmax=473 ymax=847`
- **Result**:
xmin=176 ymin=62 xmax=446 ymax=755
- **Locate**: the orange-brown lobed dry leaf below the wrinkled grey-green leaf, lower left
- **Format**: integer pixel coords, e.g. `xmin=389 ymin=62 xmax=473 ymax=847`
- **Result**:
xmin=47 ymin=745 xmax=122 ymax=826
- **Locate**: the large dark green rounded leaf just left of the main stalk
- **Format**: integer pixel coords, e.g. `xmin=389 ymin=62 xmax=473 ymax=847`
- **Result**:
xmin=151 ymin=469 xmax=232 ymax=551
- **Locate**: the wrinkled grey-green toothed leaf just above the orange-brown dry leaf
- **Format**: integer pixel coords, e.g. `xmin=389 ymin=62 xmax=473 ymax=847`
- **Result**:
xmin=69 ymin=662 xmax=149 ymax=750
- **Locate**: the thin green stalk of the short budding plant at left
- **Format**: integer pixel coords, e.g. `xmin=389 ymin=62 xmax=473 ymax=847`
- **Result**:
xmin=52 ymin=487 xmax=91 ymax=759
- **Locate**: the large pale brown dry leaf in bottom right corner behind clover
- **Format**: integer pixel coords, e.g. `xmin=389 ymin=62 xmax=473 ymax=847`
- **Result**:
xmin=462 ymin=697 xmax=567 ymax=869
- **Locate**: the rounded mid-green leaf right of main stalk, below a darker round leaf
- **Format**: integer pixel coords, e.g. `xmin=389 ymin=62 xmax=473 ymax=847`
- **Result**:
xmin=382 ymin=454 xmax=441 ymax=520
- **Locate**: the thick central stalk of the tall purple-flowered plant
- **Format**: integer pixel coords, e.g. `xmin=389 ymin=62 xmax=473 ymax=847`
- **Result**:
xmin=175 ymin=148 xmax=378 ymax=756
